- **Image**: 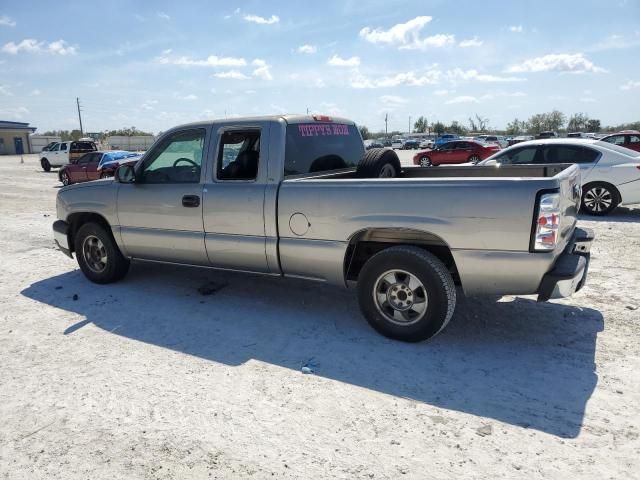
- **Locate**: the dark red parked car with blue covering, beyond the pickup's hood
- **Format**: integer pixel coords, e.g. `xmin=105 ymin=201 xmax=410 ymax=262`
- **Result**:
xmin=58 ymin=150 xmax=140 ymax=185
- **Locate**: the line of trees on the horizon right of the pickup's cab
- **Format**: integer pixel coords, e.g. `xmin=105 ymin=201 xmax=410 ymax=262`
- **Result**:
xmin=360 ymin=110 xmax=640 ymax=140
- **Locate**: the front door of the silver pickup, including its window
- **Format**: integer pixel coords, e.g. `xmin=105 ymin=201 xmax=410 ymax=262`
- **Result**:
xmin=117 ymin=128 xmax=209 ymax=265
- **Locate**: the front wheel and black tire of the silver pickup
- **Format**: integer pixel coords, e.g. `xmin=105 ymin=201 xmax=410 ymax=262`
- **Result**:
xmin=74 ymin=223 xmax=129 ymax=284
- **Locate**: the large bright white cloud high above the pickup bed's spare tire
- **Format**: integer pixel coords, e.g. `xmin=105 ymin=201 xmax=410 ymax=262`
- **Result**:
xmin=360 ymin=16 xmax=455 ymax=50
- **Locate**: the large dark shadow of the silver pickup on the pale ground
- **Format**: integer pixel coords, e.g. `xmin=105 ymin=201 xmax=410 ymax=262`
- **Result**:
xmin=22 ymin=263 xmax=603 ymax=438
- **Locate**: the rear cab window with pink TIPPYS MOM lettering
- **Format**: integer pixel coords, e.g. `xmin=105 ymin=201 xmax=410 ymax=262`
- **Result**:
xmin=284 ymin=121 xmax=364 ymax=178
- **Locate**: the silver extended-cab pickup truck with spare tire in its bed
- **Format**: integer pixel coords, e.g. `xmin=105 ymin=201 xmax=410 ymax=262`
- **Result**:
xmin=53 ymin=115 xmax=593 ymax=341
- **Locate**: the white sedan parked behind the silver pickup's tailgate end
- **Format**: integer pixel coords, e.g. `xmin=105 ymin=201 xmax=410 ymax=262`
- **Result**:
xmin=481 ymin=138 xmax=640 ymax=215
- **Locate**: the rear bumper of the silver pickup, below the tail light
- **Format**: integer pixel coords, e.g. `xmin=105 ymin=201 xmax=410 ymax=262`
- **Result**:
xmin=538 ymin=228 xmax=594 ymax=302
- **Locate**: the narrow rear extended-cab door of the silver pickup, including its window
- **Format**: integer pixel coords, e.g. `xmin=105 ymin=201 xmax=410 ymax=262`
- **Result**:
xmin=203 ymin=122 xmax=270 ymax=273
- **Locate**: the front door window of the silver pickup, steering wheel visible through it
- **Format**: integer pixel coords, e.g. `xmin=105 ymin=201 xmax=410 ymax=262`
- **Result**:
xmin=139 ymin=128 xmax=205 ymax=183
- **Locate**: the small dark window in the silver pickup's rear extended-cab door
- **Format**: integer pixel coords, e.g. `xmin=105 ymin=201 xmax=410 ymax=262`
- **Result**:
xmin=216 ymin=130 xmax=260 ymax=181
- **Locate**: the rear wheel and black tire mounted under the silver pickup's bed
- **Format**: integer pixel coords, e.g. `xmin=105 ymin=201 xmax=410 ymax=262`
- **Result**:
xmin=358 ymin=246 xmax=456 ymax=342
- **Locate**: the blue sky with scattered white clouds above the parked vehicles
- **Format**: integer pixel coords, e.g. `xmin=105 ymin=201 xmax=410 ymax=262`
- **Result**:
xmin=0 ymin=0 xmax=640 ymax=132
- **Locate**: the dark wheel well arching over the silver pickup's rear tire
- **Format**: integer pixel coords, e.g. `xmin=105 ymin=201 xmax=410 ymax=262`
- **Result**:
xmin=344 ymin=229 xmax=460 ymax=285
